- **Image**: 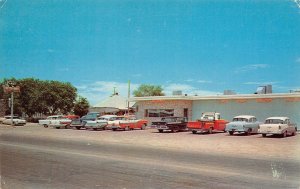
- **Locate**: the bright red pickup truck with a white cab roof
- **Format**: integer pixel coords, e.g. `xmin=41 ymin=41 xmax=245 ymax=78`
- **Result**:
xmin=187 ymin=112 xmax=229 ymax=134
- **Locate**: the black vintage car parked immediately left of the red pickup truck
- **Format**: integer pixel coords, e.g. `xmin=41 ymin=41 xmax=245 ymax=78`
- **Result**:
xmin=152 ymin=117 xmax=187 ymax=133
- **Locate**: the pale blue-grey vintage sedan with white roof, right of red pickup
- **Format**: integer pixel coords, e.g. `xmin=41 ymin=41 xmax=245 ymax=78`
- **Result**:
xmin=225 ymin=115 xmax=260 ymax=135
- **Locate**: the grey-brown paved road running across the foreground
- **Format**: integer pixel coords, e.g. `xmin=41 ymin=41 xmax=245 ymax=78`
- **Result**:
xmin=0 ymin=125 xmax=300 ymax=189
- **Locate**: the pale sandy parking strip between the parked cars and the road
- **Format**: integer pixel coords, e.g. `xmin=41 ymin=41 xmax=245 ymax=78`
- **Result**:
xmin=0 ymin=123 xmax=300 ymax=160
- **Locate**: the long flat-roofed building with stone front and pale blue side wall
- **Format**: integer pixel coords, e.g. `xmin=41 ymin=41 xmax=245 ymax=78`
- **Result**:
xmin=130 ymin=93 xmax=300 ymax=128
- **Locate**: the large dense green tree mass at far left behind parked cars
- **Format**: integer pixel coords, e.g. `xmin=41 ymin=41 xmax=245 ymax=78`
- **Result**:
xmin=0 ymin=78 xmax=77 ymax=117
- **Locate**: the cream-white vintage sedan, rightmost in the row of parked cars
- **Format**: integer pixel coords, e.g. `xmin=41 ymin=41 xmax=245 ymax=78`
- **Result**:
xmin=258 ymin=117 xmax=297 ymax=137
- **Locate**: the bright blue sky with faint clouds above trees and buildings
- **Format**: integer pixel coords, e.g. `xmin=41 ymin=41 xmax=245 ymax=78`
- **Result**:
xmin=0 ymin=0 xmax=300 ymax=105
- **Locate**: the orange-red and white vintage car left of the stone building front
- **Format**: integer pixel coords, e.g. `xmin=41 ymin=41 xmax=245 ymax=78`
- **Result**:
xmin=111 ymin=116 xmax=148 ymax=131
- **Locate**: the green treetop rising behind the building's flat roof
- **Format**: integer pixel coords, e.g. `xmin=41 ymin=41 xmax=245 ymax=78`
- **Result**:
xmin=133 ymin=84 xmax=165 ymax=97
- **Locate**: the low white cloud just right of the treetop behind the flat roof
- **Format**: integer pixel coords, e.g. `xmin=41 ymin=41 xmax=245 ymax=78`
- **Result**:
xmin=163 ymin=83 xmax=220 ymax=95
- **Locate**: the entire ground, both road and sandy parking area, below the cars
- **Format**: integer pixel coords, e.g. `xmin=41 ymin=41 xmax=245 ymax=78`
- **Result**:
xmin=0 ymin=124 xmax=300 ymax=189
